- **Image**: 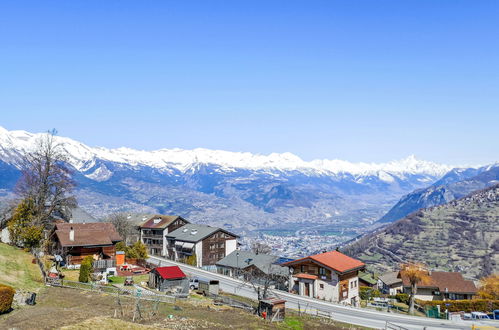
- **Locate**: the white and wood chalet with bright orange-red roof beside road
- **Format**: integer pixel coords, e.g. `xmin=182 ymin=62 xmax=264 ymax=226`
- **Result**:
xmin=283 ymin=251 xmax=365 ymax=306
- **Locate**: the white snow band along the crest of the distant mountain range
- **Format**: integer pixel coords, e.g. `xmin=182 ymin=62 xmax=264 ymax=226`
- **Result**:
xmin=0 ymin=127 xmax=453 ymax=179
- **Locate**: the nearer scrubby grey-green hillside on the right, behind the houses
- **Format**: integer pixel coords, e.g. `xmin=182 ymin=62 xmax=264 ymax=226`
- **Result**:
xmin=345 ymin=185 xmax=499 ymax=279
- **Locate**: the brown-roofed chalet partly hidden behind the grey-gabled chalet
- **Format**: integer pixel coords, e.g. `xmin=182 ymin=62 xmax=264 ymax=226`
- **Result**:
xmin=139 ymin=215 xmax=189 ymax=257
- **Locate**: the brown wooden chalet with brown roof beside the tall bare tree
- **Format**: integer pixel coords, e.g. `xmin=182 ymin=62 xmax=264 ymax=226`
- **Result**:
xmin=50 ymin=222 xmax=122 ymax=265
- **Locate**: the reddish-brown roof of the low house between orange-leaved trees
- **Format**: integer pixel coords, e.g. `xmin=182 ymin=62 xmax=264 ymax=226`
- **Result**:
xmin=402 ymin=272 xmax=478 ymax=294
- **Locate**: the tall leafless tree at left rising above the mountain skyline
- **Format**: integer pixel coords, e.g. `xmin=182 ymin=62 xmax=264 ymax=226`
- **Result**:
xmin=16 ymin=130 xmax=76 ymax=225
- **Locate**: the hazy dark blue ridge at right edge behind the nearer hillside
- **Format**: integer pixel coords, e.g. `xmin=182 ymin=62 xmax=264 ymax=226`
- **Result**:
xmin=379 ymin=164 xmax=499 ymax=223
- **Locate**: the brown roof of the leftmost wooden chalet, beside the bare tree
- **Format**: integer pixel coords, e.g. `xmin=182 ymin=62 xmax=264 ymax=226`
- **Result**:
xmin=55 ymin=222 xmax=122 ymax=247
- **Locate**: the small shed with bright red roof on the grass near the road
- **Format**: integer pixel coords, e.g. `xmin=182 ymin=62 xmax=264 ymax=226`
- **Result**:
xmin=149 ymin=266 xmax=189 ymax=294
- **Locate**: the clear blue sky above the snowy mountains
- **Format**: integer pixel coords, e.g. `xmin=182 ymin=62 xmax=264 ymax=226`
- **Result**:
xmin=0 ymin=0 xmax=499 ymax=164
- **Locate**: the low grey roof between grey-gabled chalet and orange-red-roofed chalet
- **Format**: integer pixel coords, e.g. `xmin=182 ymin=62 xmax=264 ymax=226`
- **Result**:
xmin=217 ymin=250 xmax=289 ymax=276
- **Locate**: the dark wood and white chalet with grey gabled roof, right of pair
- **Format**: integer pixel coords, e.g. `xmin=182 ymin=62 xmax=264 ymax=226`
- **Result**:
xmin=166 ymin=223 xmax=239 ymax=268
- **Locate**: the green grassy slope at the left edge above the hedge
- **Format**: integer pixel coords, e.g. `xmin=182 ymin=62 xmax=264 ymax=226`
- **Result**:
xmin=0 ymin=243 xmax=43 ymax=291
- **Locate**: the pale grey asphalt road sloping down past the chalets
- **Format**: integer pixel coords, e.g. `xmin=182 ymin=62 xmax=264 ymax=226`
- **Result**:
xmin=148 ymin=257 xmax=485 ymax=330
